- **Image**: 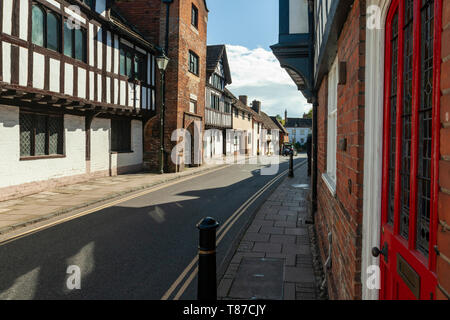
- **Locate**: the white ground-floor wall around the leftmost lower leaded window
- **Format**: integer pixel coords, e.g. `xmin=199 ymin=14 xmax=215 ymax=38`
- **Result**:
xmin=0 ymin=105 xmax=86 ymax=188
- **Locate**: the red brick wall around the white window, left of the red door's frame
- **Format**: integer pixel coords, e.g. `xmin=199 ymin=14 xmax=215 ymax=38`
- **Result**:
xmin=316 ymin=0 xmax=366 ymax=299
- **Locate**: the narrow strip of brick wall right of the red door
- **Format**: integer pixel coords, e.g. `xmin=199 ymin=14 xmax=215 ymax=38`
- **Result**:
xmin=436 ymin=0 xmax=450 ymax=300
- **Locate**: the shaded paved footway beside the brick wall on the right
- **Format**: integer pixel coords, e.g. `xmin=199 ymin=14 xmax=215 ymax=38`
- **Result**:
xmin=218 ymin=165 xmax=320 ymax=300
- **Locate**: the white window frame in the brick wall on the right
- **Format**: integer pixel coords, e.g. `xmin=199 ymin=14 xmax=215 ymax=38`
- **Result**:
xmin=322 ymin=57 xmax=339 ymax=195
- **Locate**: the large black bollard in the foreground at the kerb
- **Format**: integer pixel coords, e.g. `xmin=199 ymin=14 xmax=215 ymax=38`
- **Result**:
xmin=197 ymin=217 xmax=219 ymax=301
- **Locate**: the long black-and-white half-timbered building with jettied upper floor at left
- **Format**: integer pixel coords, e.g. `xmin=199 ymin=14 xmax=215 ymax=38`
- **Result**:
xmin=0 ymin=0 xmax=157 ymax=199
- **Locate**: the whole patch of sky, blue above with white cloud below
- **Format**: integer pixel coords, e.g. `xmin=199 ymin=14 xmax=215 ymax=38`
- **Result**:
xmin=207 ymin=0 xmax=311 ymax=117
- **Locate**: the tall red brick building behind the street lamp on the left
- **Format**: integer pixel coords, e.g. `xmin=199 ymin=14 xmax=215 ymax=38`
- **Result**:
xmin=116 ymin=0 xmax=208 ymax=171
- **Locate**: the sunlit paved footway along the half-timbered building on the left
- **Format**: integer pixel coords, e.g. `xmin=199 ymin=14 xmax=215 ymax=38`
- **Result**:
xmin=0 ymin=164 xmax=229 ymax=235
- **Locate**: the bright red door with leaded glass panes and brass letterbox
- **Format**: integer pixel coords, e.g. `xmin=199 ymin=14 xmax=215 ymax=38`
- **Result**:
xmin=374 ymin=0 xmax=442 ymax=299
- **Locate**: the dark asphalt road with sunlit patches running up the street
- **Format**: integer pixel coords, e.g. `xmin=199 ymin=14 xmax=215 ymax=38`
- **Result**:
xmin=0 ymin=158 xmax=305 ymax=299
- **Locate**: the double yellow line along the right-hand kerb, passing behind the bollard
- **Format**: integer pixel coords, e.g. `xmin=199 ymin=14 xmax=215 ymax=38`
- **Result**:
xmin=161 ymin=161 xmax=306 ymax=300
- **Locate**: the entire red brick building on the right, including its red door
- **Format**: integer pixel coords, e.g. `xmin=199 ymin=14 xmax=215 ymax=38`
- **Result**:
xmin=273 ymin=0 xmax=450 ymax=299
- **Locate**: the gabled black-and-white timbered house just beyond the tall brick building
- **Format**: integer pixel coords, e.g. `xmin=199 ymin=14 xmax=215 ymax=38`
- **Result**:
xmin=203 ymin=45 xmax=233 ymax=158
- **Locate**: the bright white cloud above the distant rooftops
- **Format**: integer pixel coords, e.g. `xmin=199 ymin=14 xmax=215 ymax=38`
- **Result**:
xmin=227 ymin=45 xmax=311 ymax=117
